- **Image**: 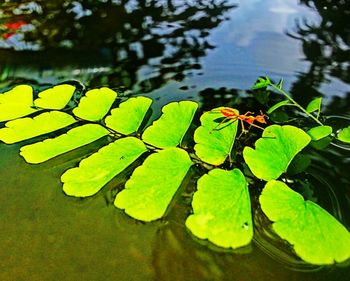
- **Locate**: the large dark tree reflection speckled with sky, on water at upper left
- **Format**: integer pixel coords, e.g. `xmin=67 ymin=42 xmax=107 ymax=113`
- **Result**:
xmin=2 ymin=0 xmax=233 ymax=92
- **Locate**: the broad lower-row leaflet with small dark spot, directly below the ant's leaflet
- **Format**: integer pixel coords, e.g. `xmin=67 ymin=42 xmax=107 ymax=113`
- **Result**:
xmin=186 ymin=169 xmax=253 ymax=249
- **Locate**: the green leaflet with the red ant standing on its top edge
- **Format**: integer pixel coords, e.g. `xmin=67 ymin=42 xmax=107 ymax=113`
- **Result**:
xmin=194 ymin=107 xmax=238 ymax=166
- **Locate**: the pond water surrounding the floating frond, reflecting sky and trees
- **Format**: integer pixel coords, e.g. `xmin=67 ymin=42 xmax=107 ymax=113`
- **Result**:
xmin=0 ymin=0 xmax=350 ymax=281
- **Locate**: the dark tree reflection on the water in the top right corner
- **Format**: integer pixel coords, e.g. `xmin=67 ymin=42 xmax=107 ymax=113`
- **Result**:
xmin=289 ymin=0 xmax=350 ymax=103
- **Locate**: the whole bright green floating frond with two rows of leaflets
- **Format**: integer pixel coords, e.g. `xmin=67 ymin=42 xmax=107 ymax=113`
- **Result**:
xmin=0 ymin=79 xmax=350 ymax=264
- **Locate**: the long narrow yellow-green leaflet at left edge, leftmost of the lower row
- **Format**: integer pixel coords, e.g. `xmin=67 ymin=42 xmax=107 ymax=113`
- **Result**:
xmin=0 ymin=111 xmax=76 ymax=143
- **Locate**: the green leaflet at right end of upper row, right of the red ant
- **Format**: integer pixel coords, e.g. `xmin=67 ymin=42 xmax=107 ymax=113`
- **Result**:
xmin=243 ymin=125 xmax=310 ymax=181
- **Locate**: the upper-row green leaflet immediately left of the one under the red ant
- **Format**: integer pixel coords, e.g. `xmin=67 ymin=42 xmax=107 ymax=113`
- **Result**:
xmin=142 ymin=101 xmax=198 ymax=148
